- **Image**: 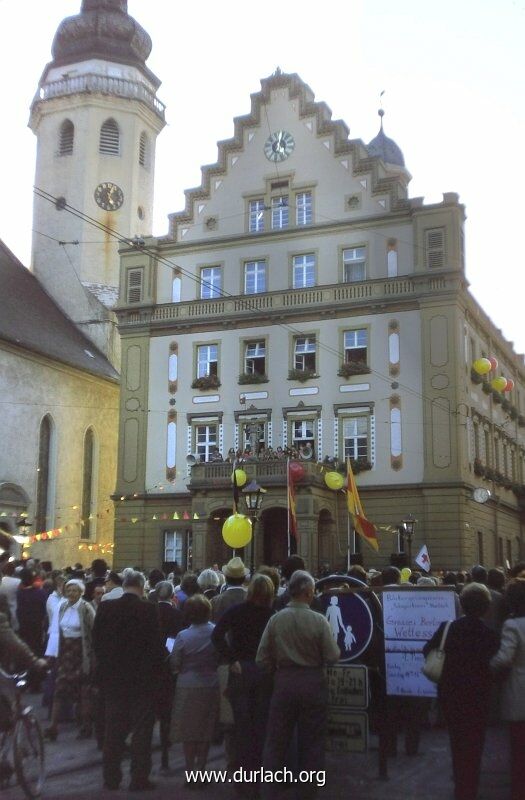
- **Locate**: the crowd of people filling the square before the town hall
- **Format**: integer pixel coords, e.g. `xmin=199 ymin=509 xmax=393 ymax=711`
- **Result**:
xmin=0 ymin=540 xmax=525 ymax=800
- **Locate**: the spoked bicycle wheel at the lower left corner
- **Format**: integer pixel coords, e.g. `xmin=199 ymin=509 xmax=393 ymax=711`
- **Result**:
xmin=13 ymin=714 xmax=45 ymax=798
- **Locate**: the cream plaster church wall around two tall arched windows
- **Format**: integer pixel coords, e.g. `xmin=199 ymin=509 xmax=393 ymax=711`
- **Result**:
xmin=0 ymin=346 xmax=119 ymax=568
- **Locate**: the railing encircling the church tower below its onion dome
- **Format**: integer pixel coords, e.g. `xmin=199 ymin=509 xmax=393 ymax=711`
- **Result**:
xmin=34 ymin=73 xmax=166 ymax=120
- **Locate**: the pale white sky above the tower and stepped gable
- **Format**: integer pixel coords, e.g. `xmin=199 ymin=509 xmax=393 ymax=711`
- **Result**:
xmin=0 ymin=0 xmax=525 ymax=353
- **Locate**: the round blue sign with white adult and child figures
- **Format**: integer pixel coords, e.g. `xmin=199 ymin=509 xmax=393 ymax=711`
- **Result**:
xmin=319 ymin=592 xmax=374 ymax=662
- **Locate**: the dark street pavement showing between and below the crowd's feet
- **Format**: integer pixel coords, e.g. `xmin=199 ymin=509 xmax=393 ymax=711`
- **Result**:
xmin=2 ymin=697 xmax=510 ymax=800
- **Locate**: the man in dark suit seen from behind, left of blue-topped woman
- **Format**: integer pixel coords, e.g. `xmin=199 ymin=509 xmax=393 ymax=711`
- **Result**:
xmin=93 ymin=570 xmax=166 ymax=791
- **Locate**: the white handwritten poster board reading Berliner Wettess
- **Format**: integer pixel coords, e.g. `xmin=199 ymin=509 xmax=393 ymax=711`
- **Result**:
xmin=381 ymin=588 xmax=456 ymax=697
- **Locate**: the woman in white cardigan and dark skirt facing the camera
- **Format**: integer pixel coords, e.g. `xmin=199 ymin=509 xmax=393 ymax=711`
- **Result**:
xmin=45 ymin=578 xmax=95 ymax=741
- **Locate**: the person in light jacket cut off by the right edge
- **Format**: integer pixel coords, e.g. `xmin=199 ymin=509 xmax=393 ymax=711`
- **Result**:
xmin=490 ymin=579 xmax=525 ymax=800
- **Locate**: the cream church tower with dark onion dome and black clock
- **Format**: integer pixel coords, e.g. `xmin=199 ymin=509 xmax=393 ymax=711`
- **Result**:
xmin=29 ymin=0 xmax=165 ymax=363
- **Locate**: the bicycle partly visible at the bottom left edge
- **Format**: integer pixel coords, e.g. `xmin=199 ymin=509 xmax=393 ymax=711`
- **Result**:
xmin=0 ymin=670 xmax=45 ymax=798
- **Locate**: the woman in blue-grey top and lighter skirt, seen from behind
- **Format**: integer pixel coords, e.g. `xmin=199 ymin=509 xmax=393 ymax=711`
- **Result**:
xmin=170 ymin=594 xmax=219 ymax=770
